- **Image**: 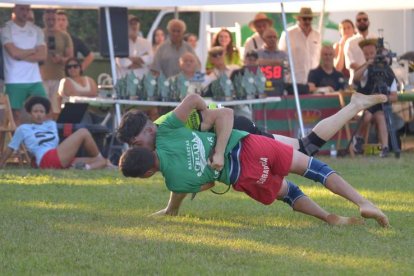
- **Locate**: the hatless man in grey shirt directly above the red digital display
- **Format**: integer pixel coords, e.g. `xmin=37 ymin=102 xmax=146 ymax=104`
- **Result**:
xmin=257 ymin=28 xmax=288 ymax=66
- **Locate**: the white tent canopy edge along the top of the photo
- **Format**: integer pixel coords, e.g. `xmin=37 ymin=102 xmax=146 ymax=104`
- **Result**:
xmin=0 ymin=0 xmax=414 ymax=12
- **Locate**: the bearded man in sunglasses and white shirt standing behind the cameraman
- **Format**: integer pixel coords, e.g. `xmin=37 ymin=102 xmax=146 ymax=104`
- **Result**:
xmin=344 ymin=12 xmax=376 ymax=85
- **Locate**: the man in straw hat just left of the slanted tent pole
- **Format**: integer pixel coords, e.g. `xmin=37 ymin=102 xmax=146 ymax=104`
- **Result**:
xmin=244 ymin=13 xmax=273 ymax=56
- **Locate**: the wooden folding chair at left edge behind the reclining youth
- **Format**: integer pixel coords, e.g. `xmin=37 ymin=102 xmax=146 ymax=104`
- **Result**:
xmin=0 ymin=93 xmax=31 ymax=165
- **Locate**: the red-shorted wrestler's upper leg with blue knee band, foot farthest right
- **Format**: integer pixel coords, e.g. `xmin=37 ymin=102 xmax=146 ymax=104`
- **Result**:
xmin=290 ymin=151 xmax=389 ymax=227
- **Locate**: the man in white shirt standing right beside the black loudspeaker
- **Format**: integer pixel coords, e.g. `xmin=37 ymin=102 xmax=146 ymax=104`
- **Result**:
xmin=116 ymin=14 xmax=154 ymax=79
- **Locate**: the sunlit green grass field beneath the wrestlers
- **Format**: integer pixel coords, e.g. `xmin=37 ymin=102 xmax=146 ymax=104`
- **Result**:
xmin=0 ymin=154 xmax=414 ymax=275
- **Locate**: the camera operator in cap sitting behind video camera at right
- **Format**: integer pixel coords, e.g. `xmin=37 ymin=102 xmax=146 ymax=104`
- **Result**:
xmin=353 ymin=39 xmax=397 ymax=157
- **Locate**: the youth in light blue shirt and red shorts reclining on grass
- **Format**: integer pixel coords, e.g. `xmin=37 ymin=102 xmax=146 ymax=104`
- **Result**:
xmin=0 ymin=96 xmax=109 ymax=170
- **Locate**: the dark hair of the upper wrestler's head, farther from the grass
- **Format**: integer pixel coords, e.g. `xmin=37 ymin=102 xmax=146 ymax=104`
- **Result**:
xmin=116 ymin=109 xmax=148 ymax=144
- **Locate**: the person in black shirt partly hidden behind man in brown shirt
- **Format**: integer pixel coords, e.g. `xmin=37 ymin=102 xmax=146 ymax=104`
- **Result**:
xmin=56 ymin=10 xmax=95 ymax=71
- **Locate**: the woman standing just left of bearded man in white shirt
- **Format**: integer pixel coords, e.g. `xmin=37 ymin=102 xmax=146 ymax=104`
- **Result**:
xmin=333 ymin=19 xmax=355 ymax=79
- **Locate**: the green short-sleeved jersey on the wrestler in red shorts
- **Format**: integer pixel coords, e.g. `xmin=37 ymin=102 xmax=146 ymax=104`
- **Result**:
xmin=156 ymin=112 xmax=248 ymax=193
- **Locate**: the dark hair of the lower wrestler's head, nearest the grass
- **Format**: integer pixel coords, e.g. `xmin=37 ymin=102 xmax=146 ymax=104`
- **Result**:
xmin=119 ymin=147 xmax=155 ymax=177
